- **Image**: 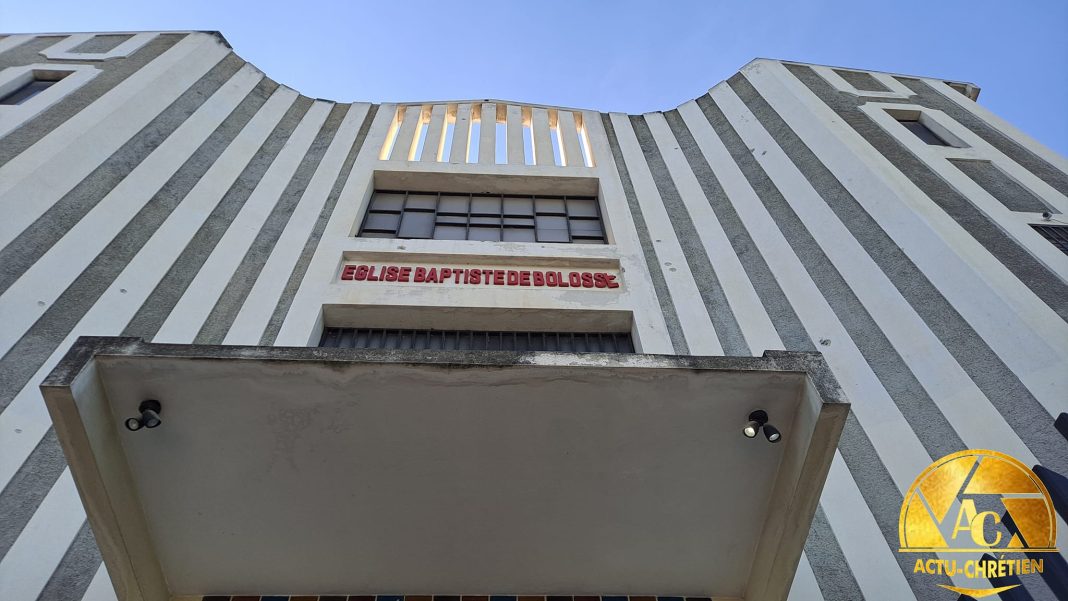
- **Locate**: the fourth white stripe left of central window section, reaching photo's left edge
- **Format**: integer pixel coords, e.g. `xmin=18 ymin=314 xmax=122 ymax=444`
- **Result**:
xmin=0 ymin=65 xmax=263 ymax=354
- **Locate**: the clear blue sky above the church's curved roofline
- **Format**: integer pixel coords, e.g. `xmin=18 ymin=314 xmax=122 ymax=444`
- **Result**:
xmin=6 ymin=0 xmax=1068 ymax=155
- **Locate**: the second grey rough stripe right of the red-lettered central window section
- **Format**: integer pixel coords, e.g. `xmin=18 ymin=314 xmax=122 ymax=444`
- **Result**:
xmin=630 ymin=115 xmax=750 ymax=355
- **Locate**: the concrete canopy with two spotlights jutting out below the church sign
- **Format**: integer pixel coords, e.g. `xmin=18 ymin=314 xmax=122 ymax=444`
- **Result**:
xmin=42 ymin=337 xmax=849 ymax=601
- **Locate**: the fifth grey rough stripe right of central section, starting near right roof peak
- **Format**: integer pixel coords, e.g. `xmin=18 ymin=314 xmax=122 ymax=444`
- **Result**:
xmin=735 ymin=69 xmax=1068 ymax=473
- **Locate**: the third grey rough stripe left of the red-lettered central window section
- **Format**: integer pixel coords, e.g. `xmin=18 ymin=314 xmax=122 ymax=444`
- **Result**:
xmin=122 ymin=96 xmax=313 ymax=341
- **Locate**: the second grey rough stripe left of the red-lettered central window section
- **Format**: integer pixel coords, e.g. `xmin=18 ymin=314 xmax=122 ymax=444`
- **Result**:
xmin=193 ymin=105 xmax=351 ymax=344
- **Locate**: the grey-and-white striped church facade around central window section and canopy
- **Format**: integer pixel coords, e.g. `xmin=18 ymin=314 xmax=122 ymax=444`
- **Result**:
xmin=0 ymin=33 xmax=1068 ymax=601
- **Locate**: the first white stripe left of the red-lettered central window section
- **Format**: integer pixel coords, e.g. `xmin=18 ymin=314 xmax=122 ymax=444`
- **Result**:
xmin=223 ymin=105 xmax=370 ymax=345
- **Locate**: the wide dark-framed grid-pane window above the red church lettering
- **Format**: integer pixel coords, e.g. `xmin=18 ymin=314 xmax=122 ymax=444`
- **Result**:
xmin=359 ymin=190 xmax=606 ymax=244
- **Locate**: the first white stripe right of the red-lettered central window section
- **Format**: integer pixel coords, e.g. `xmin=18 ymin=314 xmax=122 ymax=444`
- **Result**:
xmin=611 ymin=113 xmax=723 ymax=354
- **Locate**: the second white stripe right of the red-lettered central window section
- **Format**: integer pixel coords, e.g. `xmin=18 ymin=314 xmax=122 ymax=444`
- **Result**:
xmin=646 ymin=110 xmax=783 ymax=357
